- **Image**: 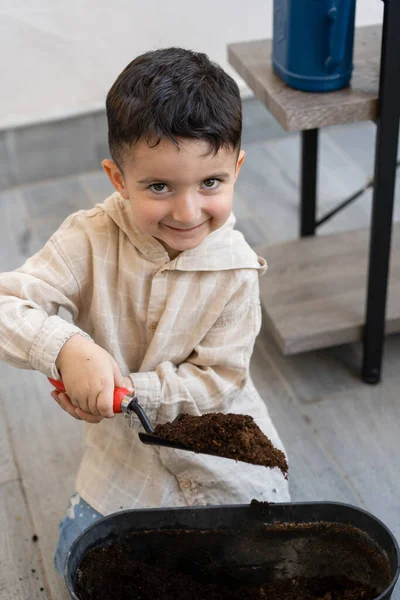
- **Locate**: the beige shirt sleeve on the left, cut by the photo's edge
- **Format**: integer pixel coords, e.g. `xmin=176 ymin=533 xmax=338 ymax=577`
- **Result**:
xmin=0 ymin=239 xmax=90 ymax=379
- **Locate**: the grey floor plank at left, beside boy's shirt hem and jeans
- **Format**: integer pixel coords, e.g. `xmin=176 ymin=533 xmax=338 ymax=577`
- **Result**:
xmin=0 ymin=363 xmax=82 ymax=600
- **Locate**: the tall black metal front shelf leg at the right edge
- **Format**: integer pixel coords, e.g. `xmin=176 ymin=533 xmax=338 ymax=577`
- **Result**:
xmin=362 ymin=0 xmax=400 ymax=383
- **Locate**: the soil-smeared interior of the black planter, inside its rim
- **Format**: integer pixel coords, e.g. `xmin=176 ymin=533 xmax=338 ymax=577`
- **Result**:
xmin=75 ymin=522 xmax=390 ymax=600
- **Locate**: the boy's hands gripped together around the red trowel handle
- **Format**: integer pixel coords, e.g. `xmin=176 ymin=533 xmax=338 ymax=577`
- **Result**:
xmin=51 ymin=334 xmax=132 ymax=423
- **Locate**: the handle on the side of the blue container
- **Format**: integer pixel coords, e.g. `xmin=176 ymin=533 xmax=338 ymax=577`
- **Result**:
xmin=325 ymin=0 xmax=355 ymax=72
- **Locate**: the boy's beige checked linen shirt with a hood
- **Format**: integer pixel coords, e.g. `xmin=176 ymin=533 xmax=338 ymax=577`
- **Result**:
xmin=0 ymin=193 xmax=289 ymax=515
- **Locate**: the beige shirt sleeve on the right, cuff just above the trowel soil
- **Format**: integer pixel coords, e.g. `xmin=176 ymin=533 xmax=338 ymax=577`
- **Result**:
xmin=130 ymin=271 xmax=261 ymax=423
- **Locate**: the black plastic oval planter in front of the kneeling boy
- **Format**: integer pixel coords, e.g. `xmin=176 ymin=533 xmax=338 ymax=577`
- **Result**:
xmin=65 ymin=502 xmax=400 ymax=600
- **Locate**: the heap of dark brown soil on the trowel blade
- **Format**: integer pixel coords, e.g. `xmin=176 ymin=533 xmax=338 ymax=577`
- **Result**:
xmin=154 ymin=413 xmax=288 ymax=475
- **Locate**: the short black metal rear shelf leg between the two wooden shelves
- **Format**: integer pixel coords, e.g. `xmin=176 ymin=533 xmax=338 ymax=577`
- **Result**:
xmin=300 ymin=129 xmax=318 ymax=237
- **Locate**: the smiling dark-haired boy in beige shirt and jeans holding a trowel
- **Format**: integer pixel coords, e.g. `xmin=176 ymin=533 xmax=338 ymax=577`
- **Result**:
xmin=0 ymin=48 xmax=289 ymax=573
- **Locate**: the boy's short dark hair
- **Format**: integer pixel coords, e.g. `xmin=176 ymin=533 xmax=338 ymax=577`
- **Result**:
xmin=106 ymin=48 xmax=242 ymax=167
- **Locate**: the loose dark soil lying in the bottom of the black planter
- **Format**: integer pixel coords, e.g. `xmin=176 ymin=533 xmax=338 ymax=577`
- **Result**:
xmin=75 ymin=545 xmax=378 ymax=600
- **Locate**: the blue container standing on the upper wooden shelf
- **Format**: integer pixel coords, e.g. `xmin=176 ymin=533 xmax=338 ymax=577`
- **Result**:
xmin=272 ymin=0 xmax=356 ymax=92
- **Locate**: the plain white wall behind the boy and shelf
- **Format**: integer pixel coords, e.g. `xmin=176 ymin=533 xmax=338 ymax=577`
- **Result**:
xmin=0 ymin=0 xmax=383 ymax=128
